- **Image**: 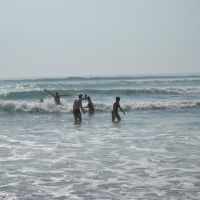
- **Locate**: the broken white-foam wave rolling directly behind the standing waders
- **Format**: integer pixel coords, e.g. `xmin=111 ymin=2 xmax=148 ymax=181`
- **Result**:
xmin=0 ymin=101 xmax=200 ymax=115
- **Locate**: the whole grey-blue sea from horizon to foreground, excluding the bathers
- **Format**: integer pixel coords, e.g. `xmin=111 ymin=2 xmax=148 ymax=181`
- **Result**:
xmin=0 ymin=75 xmax=200 ymax=200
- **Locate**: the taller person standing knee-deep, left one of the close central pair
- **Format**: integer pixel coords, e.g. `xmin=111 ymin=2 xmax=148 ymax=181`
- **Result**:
xmin=73 ymin=94 xmax=85 ymax=123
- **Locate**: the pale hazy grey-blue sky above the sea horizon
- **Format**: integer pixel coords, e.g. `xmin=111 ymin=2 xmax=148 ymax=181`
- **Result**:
xmin=0 ymin=0 xmax=200 ymax=78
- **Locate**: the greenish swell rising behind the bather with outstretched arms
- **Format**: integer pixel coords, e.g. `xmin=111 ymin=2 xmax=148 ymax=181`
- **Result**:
xmin=0 ymin=88 xmax=200 ymax=100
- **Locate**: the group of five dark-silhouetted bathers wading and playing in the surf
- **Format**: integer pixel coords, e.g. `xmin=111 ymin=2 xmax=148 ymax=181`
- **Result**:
xmin=40 ymin=89 xmax=125 ymax=123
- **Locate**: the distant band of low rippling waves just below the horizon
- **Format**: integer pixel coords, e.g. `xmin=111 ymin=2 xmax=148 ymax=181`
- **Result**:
xmin=0 ymin=75 xmax=200 ymax=91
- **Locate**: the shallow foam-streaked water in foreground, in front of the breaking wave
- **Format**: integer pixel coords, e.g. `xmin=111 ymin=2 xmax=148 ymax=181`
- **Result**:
xmin=0 ymin=111 xmax=200 ymax=199
